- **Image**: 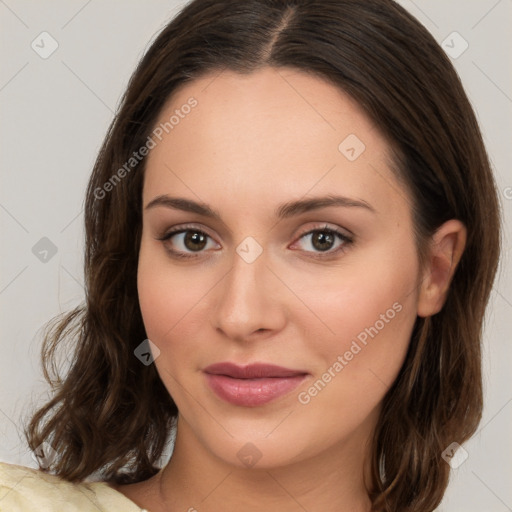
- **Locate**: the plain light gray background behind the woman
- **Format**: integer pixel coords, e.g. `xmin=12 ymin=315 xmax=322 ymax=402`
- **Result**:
xmin=0 ymin=0 xmax=512 ymax=512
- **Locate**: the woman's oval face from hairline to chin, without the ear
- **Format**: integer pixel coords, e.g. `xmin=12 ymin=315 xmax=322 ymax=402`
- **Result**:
xmin=138 ymin=68 xmax=420 ymax=467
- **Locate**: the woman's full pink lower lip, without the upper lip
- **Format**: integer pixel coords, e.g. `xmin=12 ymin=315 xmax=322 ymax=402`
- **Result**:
xmin=206 ymin=373 xmax=306 ymax=407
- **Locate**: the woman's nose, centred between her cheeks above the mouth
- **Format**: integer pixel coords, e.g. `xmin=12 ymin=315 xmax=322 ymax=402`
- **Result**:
xmin=213 ymin=247 xmax=286 ymax=341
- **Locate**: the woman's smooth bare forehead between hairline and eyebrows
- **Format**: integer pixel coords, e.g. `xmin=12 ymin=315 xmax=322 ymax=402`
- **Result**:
xmin=144 ymin=68 xmax=410 ymax=220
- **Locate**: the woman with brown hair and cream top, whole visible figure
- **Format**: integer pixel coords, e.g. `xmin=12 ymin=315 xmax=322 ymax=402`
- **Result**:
xmin=0 ymin=0 xmax=500 ymax=512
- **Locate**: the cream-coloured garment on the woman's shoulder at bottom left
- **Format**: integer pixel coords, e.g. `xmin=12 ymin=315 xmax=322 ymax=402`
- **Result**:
xmin=0 ymin=462 xmax=147 ymax=512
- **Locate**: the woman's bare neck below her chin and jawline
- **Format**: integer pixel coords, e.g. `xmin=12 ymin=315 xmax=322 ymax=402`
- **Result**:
xmin=154 ymin=419 xmax=371 ymax=512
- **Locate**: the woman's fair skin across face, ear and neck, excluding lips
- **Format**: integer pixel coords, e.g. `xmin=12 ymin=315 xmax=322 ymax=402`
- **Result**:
xmin=110 ymin=68 xmax=466 ymax=512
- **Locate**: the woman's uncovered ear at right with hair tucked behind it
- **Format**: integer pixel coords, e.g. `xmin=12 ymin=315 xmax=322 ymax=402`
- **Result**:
xmin=418 ymin=219 xmax=467 ymax=317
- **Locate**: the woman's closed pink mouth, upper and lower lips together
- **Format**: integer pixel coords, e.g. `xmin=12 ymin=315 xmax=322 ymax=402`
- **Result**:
xmin=203 ymin=362 xmax=308 ymax=407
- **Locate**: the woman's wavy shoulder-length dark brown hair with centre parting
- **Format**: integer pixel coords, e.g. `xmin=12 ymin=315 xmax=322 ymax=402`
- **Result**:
xmin=26 ymin=0 xmax=501 ymax=512
